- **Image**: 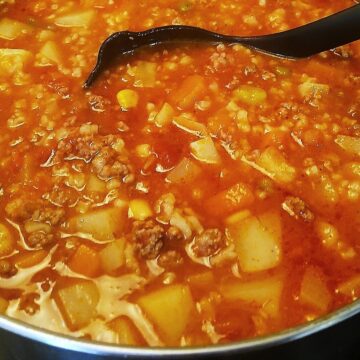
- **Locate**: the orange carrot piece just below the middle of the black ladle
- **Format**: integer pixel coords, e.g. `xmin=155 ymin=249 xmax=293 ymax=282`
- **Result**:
xmin=171 ymin=75 xmax=206 ymax=110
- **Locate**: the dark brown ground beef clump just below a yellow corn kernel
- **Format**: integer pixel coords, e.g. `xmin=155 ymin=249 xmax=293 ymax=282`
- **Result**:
xmin=132 ymin=220 xmax=166 ymax=260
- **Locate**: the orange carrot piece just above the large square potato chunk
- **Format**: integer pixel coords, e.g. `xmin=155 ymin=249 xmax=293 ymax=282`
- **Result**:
xmin=205 ymin=183 xmax=254 ymax=216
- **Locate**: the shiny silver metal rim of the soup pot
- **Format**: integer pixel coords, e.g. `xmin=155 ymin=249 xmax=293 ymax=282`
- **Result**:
xmin=0 ymin=300 xmax=360 ymax=358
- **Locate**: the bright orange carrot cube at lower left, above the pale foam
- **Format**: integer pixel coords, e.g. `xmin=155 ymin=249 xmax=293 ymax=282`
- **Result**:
xmin=68 ymin=244 xmax=100 ymax=277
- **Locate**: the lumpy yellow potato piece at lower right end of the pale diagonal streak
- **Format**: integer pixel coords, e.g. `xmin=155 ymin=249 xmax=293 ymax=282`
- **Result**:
xmin=257 ymin=147 xmax=296 ymax=183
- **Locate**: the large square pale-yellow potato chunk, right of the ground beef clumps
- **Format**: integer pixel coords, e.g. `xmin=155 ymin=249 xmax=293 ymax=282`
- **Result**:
xmin=229 ymin=213 xmax=282 ymax=272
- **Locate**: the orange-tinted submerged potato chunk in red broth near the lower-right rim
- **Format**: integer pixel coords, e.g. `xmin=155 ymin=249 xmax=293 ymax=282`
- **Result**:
xmin=299 ymin=267 xmax=332 ymax=313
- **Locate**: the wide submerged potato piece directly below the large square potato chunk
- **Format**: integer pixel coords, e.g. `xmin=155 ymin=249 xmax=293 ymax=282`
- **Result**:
xmin=220 ymin=276 xmax=284 ymax=317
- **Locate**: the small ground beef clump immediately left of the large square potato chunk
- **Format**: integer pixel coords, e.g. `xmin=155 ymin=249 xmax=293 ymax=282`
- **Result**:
xmin=192 ymin=229 xmax=225 ymax=257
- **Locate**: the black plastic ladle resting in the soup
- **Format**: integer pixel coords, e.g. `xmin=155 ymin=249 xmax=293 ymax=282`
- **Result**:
xmin=84 ymin=4 xmax=360 ymax=88
